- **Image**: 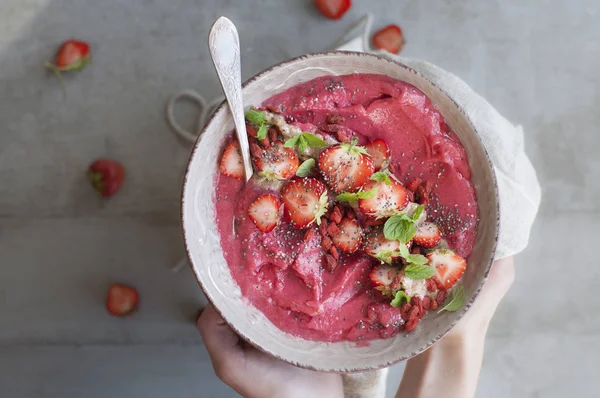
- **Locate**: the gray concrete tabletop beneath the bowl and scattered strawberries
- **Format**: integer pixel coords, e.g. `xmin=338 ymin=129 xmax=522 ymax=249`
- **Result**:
xmin=0 ymin=0 xmax=600 ymax=398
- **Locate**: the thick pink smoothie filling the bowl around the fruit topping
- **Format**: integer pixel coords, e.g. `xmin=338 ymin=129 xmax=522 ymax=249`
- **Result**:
xmin=215 ymin=74 xmax=477 ymax=341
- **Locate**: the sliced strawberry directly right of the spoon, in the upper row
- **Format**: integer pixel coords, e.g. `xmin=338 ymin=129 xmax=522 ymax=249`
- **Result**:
xmin=253 ymin=141 xmax=299 ymax=180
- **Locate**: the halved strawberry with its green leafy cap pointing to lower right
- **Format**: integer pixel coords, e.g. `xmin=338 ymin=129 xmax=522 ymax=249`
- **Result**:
xmin=281 ymin=178 xmax=329 ymax=228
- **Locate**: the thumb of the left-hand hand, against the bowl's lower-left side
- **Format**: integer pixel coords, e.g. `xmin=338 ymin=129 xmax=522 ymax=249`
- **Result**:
xmin=197 ymin=304 xmax=244 ymax=383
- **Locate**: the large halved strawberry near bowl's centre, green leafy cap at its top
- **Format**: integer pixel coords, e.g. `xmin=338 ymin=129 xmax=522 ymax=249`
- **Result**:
xmin=319 ymin=141 xmax=375 ymax=193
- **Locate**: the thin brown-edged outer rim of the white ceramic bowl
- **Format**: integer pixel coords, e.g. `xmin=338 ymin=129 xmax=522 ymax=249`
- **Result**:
xmin=180 ymin=50 xmax=500 ymax=374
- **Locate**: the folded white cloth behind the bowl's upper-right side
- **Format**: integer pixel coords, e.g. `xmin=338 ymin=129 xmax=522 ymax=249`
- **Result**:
xmin=337 ymin=15 xmax=541 ymax=259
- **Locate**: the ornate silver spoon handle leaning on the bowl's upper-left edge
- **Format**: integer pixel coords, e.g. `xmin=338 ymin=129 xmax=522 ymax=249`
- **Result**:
xmin=208 ymin=17 xmax=253 ymax=181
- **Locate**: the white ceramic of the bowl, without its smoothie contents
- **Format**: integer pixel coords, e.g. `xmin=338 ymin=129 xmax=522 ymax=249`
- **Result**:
xmin=181 ymin=52 xmax=499 ymax=372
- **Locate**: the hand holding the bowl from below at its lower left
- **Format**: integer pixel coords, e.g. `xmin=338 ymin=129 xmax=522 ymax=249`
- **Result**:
xmin=197 ymin=304 xmax=344 ymax=398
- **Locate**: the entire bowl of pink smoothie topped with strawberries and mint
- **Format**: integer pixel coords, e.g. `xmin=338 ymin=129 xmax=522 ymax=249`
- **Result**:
xmin=182 ymin=52 xmax=499 ymax=372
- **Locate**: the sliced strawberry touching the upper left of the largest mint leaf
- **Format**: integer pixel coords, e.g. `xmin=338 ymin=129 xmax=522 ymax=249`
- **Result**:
xmin=358 ymin=177 xmax=408 ymax=218
